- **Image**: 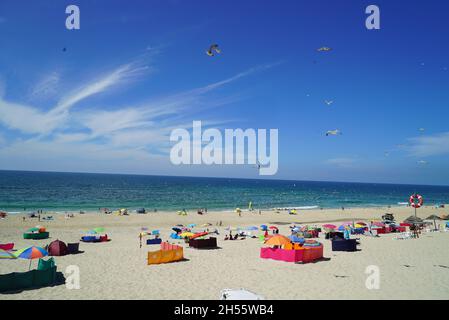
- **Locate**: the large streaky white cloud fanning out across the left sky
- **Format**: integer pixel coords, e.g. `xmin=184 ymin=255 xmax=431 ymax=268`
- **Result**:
xmin=0 ymin=53 xmax=277 ymax=171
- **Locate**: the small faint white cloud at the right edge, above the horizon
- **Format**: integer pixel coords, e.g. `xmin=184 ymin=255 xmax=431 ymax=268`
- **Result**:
xmin=402 ymin=132 xmax=449 ymax=157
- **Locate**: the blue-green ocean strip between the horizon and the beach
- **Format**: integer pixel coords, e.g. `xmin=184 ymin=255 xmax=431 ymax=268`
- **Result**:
xmin=0 ymin=171 xmax=449 ymax=213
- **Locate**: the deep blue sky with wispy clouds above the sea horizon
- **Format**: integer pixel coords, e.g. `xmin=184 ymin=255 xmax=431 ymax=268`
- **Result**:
xmin=0 ymin=0 xmax=449 ymax=184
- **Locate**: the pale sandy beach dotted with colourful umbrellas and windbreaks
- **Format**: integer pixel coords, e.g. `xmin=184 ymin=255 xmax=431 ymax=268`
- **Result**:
xmin=0 ymin=207 xmax=449 ymax=300
